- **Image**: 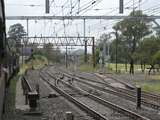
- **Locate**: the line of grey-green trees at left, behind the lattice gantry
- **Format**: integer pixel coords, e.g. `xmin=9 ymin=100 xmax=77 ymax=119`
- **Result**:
xmin=7 ymin=23 xmax=64 ymax=63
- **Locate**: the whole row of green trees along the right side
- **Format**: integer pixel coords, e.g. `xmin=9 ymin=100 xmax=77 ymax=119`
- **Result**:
xmin=97 ymin=11 xmax=160 ymax=74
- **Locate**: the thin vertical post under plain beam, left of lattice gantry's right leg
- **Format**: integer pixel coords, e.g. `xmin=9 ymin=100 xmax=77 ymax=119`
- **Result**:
xmin=84 ymin=19 xmax=87 ymax=63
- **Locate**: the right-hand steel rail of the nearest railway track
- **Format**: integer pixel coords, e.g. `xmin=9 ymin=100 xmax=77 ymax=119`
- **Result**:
xmin=40 ymin=68 xmax=152 ymax=120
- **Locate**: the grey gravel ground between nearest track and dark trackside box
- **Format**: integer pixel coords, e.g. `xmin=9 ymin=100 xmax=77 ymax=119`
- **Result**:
xmin=10 ymin=70 xmax=93 ymax=120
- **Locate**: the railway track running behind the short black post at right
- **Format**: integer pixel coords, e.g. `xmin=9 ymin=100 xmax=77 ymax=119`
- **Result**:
xmin=52 ymin=68 xmax=160 ymax=110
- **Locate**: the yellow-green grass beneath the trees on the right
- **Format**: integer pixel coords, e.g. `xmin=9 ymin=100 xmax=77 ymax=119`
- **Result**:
xmin=78 ymin=63 xmax=160 ymax=93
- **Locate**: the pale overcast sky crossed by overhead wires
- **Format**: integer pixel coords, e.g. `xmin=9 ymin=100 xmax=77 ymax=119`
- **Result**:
xmin=5 ymin=0 xmax=160 ymax=51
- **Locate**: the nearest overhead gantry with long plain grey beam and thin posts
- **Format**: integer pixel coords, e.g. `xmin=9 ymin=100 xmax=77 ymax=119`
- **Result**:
xmin=6 ymin=15 xmax=160 ymax=62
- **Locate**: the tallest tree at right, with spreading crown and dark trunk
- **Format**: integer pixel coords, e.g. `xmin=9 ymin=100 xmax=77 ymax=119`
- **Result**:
xmin=113 ymin=11 xmax=151 ymax=74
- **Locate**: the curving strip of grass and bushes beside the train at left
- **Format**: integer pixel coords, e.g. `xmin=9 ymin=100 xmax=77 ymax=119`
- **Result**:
xmin=3 ymin=55 xmax=48 ymax=120
